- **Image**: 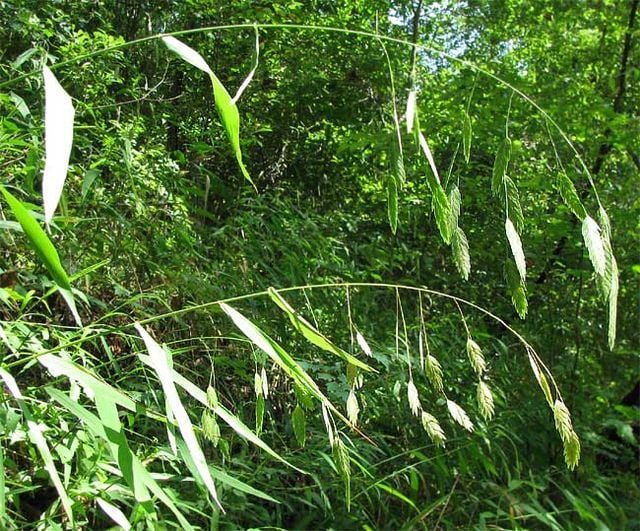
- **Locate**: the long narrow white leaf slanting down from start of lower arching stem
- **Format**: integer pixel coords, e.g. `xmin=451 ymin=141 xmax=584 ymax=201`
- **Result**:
xmin=134 ymin=323 xmax=222 ymax=509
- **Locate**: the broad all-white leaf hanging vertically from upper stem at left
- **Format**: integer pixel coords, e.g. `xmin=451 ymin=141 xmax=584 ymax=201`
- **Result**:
xmin=42 ymin=65 xmax=75 ymax=225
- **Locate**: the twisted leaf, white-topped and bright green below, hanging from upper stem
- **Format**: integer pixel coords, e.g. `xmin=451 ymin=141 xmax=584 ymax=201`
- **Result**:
xmin=162 ymin=37 xmax=255 ymax=188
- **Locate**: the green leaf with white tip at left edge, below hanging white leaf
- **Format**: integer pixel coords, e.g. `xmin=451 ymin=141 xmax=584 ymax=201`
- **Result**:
xmin=0 ymin=185 xmax=82 ymax=326
